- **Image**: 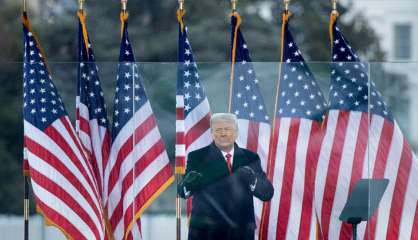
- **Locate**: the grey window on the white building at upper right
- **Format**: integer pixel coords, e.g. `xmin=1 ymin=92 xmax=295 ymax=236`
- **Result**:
xmin=394 ymin=23 xmax=412 ymax=60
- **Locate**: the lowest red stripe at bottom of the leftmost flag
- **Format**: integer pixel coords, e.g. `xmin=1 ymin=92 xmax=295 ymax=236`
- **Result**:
xmin=35 ymin=196 xmax=85 ymax=239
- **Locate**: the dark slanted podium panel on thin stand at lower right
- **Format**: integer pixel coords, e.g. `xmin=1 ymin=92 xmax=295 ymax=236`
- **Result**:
xmin=340 ymin=179 xmax=389 ymax=240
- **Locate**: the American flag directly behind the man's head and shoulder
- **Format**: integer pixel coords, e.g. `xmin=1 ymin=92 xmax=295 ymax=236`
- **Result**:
xmin=231 ymin=13 xmax=271 ymax=237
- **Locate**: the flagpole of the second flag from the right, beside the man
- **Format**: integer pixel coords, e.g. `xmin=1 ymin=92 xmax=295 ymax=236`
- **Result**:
xmin=258 ymin=0 xmax=290 ymax=240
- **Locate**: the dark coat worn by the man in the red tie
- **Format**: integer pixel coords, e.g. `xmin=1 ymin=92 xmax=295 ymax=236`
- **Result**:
xmin=179 ymin=143 xmax=274 ymax=230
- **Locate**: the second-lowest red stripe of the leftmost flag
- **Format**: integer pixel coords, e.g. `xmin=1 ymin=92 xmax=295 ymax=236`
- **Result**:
xmin=31 ymin=168 xmax=101 ymax=239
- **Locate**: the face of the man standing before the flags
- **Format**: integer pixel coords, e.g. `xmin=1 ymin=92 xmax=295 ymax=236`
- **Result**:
xmin=212 ymin=120 xmax=238 ymax=152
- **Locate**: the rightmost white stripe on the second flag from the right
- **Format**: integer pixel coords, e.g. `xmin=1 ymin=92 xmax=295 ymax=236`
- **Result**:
xmin=284 ymin=119 xmax=312 ymax=239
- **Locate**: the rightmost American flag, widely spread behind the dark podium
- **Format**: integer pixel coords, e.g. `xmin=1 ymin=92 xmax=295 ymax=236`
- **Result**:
xmin=315 ymin=15 xmax=418 ymax=239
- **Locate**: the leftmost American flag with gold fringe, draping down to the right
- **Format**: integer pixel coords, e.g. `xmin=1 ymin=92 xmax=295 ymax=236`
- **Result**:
xmin=23 ymin=14 xmax=105 ymax=239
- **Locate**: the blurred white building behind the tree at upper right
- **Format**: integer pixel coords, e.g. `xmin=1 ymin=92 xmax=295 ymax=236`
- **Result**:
xmin=341 ymin=0 xmax=418 ymax=152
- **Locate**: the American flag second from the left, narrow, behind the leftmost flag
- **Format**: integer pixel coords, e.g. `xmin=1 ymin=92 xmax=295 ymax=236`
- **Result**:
xmin=76 ymin=12 xmax=110 ymax=202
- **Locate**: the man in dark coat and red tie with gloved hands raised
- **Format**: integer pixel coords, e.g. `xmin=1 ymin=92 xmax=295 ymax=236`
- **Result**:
xmin=179 ymin=113 xmax=274 ymax=240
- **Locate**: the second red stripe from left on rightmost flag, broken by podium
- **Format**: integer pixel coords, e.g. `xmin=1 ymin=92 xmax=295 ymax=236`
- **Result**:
xmin=340 ymin=113 xmax=369 ymax=240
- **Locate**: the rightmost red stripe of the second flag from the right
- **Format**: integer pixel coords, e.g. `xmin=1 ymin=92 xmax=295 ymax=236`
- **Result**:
xmin=298 ymin=121 xmax=325 ymax=240
